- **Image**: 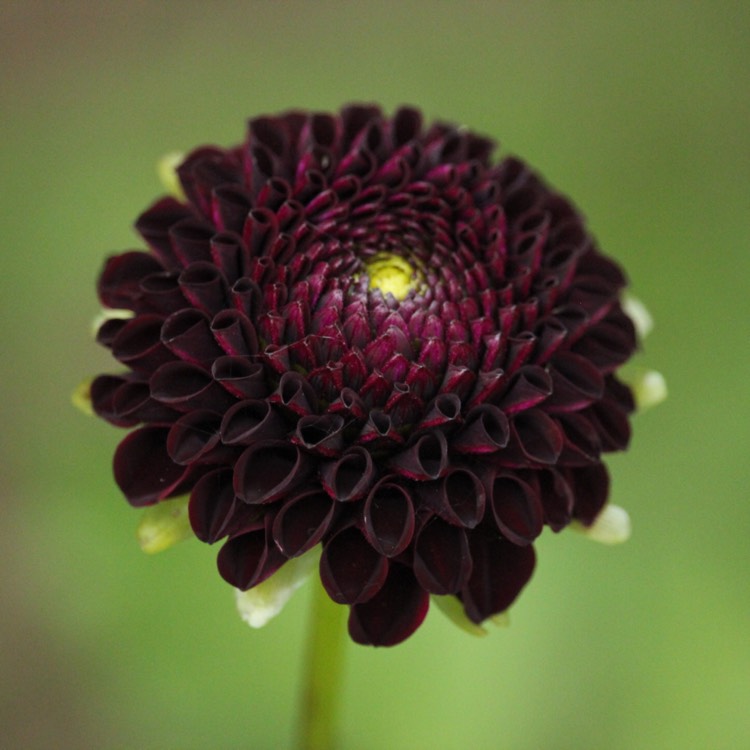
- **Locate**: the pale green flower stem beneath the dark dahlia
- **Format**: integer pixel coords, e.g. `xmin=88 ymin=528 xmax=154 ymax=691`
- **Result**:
xmin=299 ymin=576 xmax=347 ymax=750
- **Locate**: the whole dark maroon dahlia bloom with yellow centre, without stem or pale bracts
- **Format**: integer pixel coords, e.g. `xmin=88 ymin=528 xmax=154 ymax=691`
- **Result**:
xmin=91 ymin=106 xmax=636 ymax=645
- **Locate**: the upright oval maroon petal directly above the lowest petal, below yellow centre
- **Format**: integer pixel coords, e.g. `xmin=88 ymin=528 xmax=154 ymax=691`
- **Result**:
xmin=363 ymin=477 xmax=414 ymax=557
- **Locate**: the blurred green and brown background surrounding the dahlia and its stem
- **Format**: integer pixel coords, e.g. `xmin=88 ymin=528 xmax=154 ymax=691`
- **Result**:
xmin=0 ymin=0 xmax=750 ymax=750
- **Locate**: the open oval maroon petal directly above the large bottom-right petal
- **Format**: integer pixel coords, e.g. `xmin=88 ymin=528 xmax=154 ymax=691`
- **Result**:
xmin=490 ymin=473 xmax=544 ymax=545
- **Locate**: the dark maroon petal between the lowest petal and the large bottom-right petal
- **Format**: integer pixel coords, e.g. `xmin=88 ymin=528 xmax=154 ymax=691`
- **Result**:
xmin=414 ymin=516 xmax=471 ymax=595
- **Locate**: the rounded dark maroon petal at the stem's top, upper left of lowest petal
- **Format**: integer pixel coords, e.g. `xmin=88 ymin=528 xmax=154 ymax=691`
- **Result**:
xmin=320 ymin=527 xmax=389 ymax=604
